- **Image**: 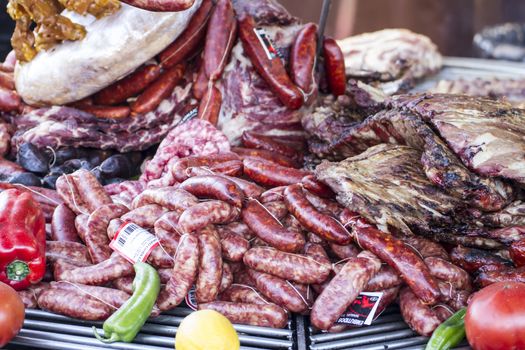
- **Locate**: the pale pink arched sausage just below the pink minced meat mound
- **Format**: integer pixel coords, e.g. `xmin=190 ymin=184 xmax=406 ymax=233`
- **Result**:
xmin=131 ymin=186 xmax=199 ymax=213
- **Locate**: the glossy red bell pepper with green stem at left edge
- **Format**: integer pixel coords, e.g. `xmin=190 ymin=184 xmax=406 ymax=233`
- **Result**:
xmin=0 ymin=189 xmax=46 ymax=290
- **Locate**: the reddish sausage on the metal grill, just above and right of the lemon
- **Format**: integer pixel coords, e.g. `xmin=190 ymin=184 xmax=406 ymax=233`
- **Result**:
xmin=199 ymin=301 xmax=288 ymax=328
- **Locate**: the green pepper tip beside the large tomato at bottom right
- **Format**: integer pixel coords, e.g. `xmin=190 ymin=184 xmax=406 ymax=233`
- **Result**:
xmin=425 ymin=308 xmax=467 ymax=350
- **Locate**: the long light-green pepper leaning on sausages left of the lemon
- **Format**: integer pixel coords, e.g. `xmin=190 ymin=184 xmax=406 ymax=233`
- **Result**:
xmin=93 ymin=262 xmax=160 ymax=343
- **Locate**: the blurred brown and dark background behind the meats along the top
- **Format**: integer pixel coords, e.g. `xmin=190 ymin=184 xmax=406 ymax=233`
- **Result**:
xmin=0 ymin=0 xmax=525 ymax=58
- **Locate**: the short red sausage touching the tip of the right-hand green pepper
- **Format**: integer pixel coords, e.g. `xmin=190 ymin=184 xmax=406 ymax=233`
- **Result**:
xmin=399 ymin=287 xmax=441 ymax=337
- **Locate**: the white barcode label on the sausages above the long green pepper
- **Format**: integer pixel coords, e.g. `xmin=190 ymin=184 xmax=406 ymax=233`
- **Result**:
xmin=109 ymin=222 xmax=159 ymax=264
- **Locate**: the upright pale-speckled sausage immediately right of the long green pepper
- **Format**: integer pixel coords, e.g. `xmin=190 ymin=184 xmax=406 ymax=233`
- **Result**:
xmin=157 ymin=235 xmax=199 ymax=311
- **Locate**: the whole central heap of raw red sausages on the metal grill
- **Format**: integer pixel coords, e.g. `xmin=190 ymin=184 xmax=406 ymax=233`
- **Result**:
xmin=14 ymin=129 xmax=472 ymax=335
